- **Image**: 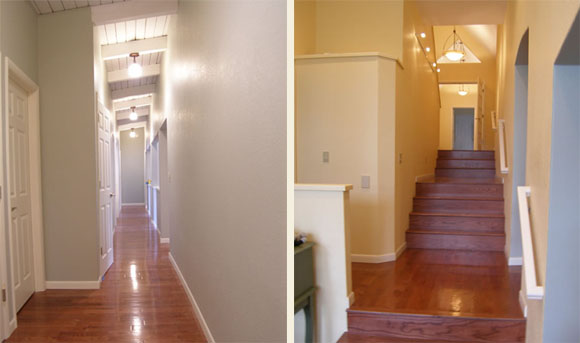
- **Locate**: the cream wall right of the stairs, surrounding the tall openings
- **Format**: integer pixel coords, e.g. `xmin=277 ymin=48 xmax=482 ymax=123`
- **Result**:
xmin=498 ymin=1 xmax=580 ymax=342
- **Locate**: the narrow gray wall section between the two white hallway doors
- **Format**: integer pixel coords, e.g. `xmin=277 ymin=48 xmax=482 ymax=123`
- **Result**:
xmin=38 ymin=8 xmax=99 ymax=281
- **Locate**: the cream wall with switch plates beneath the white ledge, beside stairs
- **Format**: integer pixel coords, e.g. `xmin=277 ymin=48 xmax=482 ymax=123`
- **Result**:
xmin=296 ymin=56 xmax=396 ymax=255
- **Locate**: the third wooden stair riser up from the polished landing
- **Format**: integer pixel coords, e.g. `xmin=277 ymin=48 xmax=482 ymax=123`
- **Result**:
xmin=413 ymin=198 xmax=503 ymax=214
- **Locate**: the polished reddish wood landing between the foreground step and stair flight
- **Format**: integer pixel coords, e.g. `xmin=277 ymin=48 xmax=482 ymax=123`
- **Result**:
xmin=351 ymin=249 xmax=523 ymax=319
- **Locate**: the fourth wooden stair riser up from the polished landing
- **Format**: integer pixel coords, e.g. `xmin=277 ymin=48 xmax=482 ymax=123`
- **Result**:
xmin=416 ymin=183 xmax=503 ymax=197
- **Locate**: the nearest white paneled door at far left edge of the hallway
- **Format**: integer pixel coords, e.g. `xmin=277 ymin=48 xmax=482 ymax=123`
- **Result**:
xmin=8 ymin=80 xmax=34 ymax=311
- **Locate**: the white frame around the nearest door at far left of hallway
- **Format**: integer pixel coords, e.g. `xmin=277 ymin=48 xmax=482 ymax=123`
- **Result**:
xmin=0 ymin=57 xmax=46 ymax=334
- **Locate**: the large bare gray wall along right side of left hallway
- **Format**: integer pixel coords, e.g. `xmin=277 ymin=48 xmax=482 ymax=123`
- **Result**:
xmin=157 ymin=0 xmax=286 ymax=342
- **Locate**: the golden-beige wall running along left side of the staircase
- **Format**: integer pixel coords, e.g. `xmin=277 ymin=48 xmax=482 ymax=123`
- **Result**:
xmin=391 ymin=1 xmax=439 ymax=253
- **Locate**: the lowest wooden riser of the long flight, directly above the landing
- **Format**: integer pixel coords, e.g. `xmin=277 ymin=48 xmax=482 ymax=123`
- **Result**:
xmin=407 ymin=231 xmax=505 ymax=251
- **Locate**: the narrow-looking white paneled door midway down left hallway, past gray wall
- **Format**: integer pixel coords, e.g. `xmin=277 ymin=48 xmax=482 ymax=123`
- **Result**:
xmin=97 ymin=102 xmax=114 ymax=275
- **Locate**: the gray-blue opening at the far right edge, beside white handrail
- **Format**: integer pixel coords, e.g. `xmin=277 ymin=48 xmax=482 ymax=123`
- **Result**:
xmin=543 ymin=12 xmax=580 ymax=342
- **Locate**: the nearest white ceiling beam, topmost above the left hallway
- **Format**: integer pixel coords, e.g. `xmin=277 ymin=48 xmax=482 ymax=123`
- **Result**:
xmin=91 ymin=0 xmax=177 ymax=25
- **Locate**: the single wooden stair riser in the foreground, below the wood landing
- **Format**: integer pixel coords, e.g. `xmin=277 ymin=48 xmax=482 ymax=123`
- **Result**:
xmin=348 ymin=312 xmax=525 ymax=343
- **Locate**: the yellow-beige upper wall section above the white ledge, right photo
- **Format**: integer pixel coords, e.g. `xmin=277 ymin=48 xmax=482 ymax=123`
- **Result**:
xmin=294 ymin=0 xmax=403 ymax=58
